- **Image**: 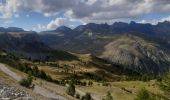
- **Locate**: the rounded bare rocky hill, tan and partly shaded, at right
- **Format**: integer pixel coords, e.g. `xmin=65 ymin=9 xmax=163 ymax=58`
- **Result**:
xmin=101 ymin=35 xmax=170 ymax=74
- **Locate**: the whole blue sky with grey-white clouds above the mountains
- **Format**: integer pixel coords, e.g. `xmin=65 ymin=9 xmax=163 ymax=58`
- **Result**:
xmin=0 ymin=0 xmax=170 ymax=31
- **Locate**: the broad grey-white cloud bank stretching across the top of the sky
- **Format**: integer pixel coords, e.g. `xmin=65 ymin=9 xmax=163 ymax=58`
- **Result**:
xmin=0 ymin=0 xmax=170 ymax=23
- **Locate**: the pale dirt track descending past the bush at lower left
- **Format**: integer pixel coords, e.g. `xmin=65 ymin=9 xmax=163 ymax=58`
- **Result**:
xmin=0 ymin=63 xmax=66 ymax=100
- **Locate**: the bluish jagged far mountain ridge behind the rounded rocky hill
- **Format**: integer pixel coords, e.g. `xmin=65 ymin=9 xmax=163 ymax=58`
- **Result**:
xmin=40 ymin=21 xmax=170 ymax=53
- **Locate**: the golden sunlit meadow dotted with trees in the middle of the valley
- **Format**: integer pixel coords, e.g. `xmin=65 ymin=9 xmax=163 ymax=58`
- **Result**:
xmin=24 ymin=54 xmax=121 ymax=81
